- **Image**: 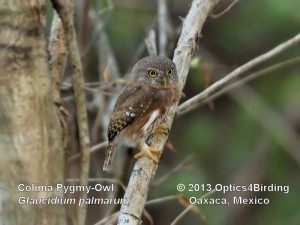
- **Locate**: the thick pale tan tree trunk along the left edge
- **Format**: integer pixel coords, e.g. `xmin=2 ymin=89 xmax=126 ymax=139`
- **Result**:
xmin=0 ymin=0 xmax=65 ymax=225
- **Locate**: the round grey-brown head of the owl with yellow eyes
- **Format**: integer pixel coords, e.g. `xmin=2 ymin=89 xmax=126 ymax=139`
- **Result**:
xmin=131 ymin=56 xmax=178 ymax=88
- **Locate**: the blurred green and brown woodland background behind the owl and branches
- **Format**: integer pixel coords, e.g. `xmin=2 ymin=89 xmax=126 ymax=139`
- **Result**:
xmin=49 ymin=0 xmax=300 ymax=225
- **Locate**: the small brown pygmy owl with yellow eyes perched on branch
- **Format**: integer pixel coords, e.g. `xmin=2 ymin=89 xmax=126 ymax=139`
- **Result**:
xmin=103 ymin=56 xmax=179 ymax=170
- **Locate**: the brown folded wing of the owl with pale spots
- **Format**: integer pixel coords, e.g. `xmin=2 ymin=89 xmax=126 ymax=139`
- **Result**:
xmin=108 ymin=85 xmax=153 ymax=141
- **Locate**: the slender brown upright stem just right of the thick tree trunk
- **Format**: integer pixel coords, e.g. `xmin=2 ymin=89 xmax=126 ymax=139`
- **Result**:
xmin=52 ymin=0 xmax=90 ymax=225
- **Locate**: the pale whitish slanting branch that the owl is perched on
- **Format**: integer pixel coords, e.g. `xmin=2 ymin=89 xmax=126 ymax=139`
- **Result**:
xmin=118 ymin=0 xmax=219 ymax=225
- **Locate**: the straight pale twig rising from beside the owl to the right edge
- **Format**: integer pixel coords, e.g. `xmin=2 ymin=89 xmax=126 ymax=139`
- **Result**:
xmin=177 ymin=34 xmax=300 ymax=115
